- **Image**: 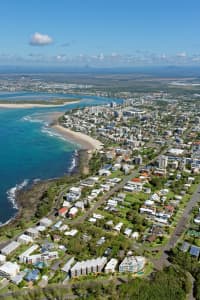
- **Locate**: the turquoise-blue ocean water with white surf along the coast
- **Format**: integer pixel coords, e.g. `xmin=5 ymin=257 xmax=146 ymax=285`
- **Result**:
xmin=0 ymin=93 xmax=119 ymax=223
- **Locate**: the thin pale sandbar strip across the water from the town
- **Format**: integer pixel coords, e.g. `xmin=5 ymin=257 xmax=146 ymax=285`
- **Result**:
xmin=0 ymin=101 xmax=80 ymax=108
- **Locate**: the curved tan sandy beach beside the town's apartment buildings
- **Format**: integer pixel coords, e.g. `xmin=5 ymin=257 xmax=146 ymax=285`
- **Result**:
xmin=52 ymin=125 xmax=103 ymax=151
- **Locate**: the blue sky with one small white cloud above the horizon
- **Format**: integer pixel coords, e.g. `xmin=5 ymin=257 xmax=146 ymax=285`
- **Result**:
xmin=0 ymin=0 xmax=200 ymax=67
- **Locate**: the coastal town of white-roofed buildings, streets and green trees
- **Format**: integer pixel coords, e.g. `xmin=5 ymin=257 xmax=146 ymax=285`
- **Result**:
xmin=0 ymin=93 xmax=200 ymax=287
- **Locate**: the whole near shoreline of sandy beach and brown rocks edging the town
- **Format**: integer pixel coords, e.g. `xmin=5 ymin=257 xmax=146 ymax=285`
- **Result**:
xmin=0 ymin=112 xmax=103 ymax=228
